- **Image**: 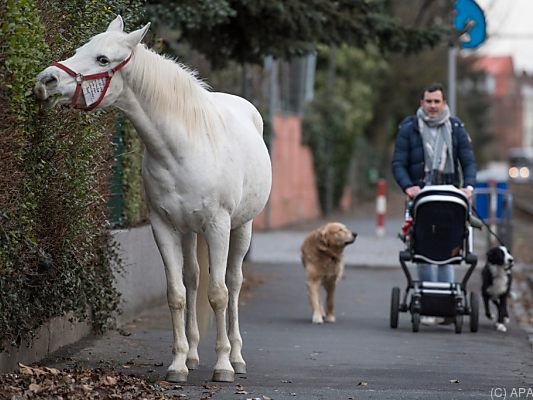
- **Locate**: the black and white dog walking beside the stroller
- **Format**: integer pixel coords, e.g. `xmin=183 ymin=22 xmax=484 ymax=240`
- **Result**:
xmin=481 ymin=246 xmax=514 ymax=332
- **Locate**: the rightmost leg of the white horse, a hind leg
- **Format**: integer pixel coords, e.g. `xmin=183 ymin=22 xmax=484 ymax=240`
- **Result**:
xmin=226 ymin=221 xmax=252 ymax=374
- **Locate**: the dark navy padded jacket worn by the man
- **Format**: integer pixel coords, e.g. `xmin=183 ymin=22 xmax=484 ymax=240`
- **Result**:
xmin=392 ymin=116 xmax=476 ymax=190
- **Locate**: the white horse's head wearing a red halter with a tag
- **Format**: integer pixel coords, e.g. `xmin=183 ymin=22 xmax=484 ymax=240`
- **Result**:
xmin=33 ymin=16 xmax=150 ymax=110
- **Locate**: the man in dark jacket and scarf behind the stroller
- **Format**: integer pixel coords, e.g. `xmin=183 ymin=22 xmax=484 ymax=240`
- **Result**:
xmin=392 ymin=83 xmax=476 ymax=282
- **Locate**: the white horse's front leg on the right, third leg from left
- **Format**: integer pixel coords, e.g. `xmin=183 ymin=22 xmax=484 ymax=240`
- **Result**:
xmin=205 ymin=216 xmax=235 ymax=382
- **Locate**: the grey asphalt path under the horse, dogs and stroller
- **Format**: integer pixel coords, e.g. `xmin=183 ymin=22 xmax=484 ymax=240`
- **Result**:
xmin=46 ymin=264 xmax=533 ymax=400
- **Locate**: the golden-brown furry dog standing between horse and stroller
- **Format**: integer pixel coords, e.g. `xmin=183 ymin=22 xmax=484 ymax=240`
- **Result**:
xmin=301 ymin=222 xmax=357 ymax=324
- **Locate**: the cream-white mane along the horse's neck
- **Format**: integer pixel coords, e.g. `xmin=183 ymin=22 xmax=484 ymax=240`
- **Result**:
xmin=129 ymin=44 xmax=222 ymax=136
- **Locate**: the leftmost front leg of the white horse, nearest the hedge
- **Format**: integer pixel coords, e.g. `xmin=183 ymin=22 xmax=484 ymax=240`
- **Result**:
xmin=150 ymin=217 xmax=189 ymax=382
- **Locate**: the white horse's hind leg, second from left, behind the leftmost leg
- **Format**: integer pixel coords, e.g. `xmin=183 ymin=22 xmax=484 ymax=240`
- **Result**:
xmin=182 ymin=233 xmax=200 ymax=369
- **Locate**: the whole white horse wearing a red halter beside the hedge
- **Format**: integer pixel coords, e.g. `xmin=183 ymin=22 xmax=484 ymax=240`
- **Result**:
xmin=34 ymin=16 xmax=272 ymax=382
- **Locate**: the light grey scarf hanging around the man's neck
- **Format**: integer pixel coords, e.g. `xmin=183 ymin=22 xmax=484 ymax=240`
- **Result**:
xmin=416 ymin=105 xmax=454 ymax=184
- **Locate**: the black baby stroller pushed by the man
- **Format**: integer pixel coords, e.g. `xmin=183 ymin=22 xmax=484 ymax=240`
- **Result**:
xmin=390 ymin=185 xmax=479 ymax=333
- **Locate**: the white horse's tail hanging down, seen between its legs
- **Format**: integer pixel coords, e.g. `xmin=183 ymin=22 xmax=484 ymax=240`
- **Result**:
xmin=196 ymin=234 xmax=211 ymax=337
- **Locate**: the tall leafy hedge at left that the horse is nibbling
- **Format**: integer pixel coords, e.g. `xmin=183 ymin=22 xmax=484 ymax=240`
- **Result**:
xmin=0 ymin=0 xmax=142 ymax=348
